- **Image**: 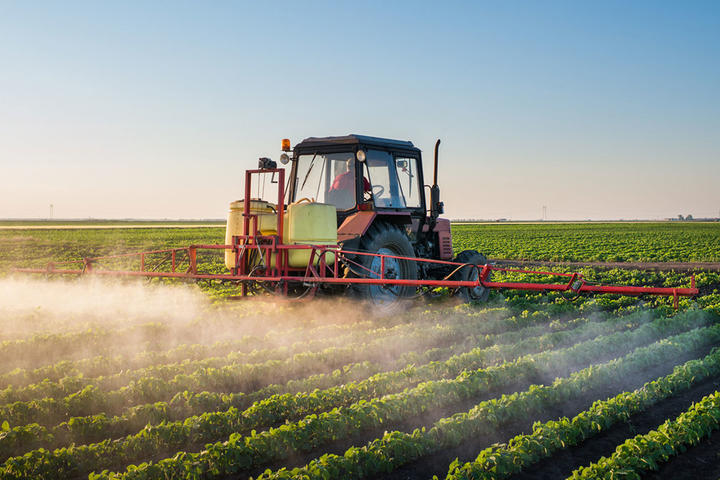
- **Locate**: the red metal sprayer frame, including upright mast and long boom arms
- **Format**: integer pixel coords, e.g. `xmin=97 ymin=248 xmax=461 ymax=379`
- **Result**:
xmin=15 ymin=169 xmax=698 ymax=307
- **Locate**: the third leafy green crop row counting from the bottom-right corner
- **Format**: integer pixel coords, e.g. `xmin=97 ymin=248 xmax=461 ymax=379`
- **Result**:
xmin=240 ymin=323 xmax=720 ymax=479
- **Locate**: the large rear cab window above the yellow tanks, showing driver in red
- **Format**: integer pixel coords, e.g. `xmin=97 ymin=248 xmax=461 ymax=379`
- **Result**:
xmin=293 ymin=152 xmax=355 ymax=210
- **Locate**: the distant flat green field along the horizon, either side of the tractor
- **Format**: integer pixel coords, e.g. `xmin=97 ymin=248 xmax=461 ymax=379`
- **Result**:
xmin=0 ymin=221 xmax=720 ymax=272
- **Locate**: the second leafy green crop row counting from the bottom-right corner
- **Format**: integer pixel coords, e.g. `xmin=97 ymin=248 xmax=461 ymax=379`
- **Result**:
xmin=447 ymin=344 xmax=720 ymax=480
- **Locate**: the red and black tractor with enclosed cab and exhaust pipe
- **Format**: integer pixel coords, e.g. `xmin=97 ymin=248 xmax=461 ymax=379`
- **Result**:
xmin=226 ymin=135 xmax=489 ymax=307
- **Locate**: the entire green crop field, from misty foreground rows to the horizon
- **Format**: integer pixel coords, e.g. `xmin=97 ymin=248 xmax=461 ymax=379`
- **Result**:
xmin=0 ymin=223 xmax=720 ymax=480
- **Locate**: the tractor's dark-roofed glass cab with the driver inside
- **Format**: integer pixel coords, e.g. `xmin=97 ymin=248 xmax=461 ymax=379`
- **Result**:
xmin=288 ymin=135 xmax=425 ymax=226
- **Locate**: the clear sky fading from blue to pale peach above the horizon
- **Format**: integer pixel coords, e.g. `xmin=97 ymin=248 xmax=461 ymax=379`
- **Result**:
xmin=0 ymin=0 xmax=720 ymax=220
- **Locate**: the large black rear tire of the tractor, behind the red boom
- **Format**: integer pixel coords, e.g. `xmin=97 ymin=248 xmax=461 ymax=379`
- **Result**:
xmin=348 ymin=222 xmax=417 ymax=311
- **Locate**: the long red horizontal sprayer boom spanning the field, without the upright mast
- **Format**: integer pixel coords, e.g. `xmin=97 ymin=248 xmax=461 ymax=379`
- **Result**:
xmin=15 ymin=244 xmax=698 ymax=307
